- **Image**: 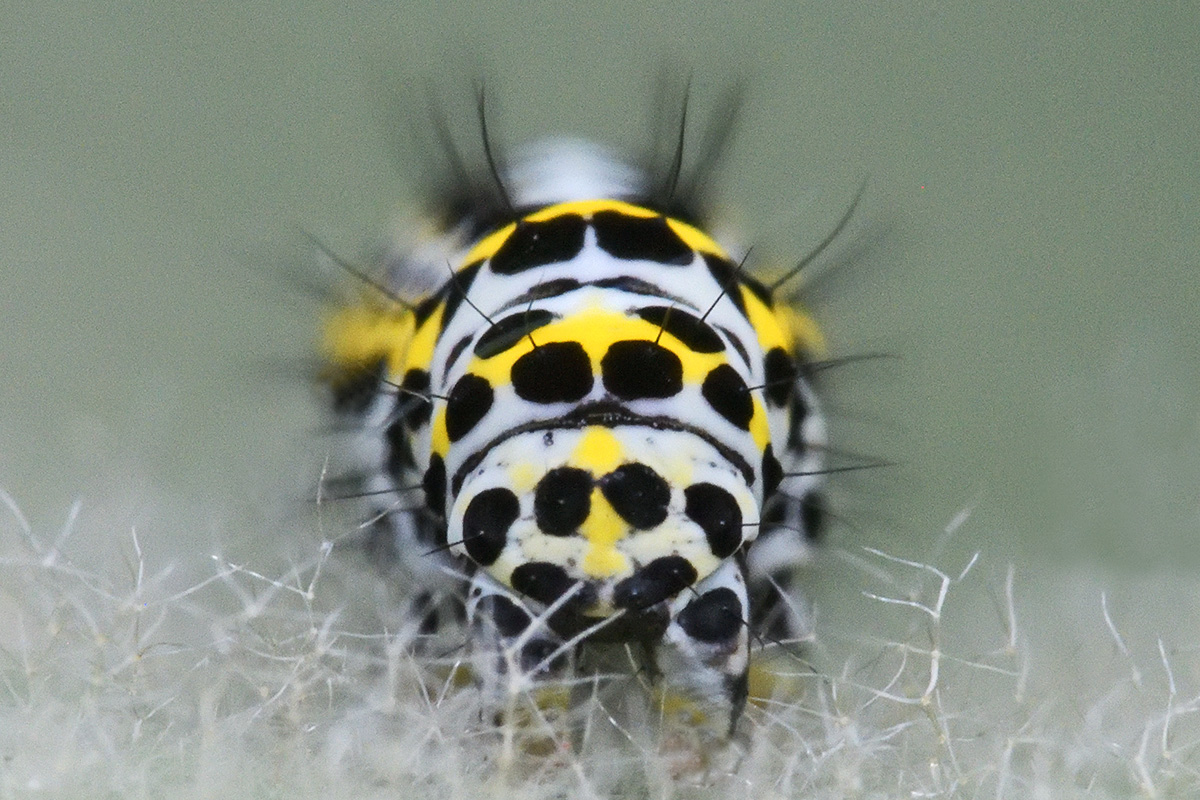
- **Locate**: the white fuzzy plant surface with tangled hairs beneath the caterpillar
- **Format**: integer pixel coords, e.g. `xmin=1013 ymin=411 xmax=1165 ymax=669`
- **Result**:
xmin=0 ymin=482 xmax=1200 ymax=800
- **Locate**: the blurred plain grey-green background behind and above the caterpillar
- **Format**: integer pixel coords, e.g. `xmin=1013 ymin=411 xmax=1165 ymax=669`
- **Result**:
xmin=0 ymin=0 xmax=1200 ymax=570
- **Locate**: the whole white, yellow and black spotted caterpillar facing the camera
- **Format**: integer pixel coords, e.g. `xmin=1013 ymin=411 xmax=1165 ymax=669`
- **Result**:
xmin=323 ymin=95 xmax=857 ymax=732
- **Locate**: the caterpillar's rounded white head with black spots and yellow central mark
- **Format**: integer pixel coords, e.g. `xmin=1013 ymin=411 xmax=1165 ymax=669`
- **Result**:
xmin=448 ymin=425 xmax=758 ymax=616
